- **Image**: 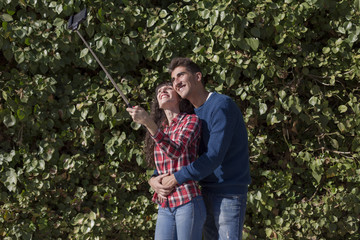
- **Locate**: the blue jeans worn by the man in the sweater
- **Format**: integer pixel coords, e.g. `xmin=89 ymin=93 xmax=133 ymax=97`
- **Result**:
xmin=203 ymin=192 xmax=247 ymax=240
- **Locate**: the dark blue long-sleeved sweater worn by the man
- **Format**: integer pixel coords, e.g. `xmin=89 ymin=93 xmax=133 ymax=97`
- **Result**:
xmin=174 ymin=92 xmax=251 ymax=194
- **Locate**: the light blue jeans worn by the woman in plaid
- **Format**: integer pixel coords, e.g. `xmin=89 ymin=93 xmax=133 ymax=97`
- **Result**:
xmin=155 ymin=196 xmax=206 ymax=240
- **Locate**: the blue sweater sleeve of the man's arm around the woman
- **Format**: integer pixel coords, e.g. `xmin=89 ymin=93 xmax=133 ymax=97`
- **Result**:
xmin=174 ymin=99 xmax=238 ymax=184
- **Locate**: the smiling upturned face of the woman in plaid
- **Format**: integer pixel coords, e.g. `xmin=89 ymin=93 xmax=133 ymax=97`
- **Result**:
xmin=156 ymin=85 xmax=180 ymax=109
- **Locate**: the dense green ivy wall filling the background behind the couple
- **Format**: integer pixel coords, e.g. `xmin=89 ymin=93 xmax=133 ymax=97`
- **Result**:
xmin=0 ymin=0 xmax=360 ymax=240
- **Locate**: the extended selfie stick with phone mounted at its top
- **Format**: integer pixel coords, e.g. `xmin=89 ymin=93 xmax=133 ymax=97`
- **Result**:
xmin=68 ymin=8 xmax=132 ymax=108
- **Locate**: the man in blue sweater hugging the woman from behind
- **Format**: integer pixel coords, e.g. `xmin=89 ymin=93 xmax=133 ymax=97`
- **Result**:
xmin=149 ymin=58 xmax=251 ymax=239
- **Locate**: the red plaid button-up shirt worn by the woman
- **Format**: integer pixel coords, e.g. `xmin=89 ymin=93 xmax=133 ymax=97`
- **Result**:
xmin=153 ymin=113 xmax=201 ymax=208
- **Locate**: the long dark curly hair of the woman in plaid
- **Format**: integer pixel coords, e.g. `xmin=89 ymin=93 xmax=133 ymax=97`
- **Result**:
xmin=144 ymin=82 xmax=194 ymax=166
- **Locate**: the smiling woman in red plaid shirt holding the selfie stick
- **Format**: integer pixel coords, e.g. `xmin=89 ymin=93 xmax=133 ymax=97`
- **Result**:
xmin=126 ymin=83 xmax=206 ymax=240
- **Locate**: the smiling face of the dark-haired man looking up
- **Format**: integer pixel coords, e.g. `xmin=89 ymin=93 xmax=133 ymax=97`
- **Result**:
xmin=171 ymin=66 xmax=199 ymax=99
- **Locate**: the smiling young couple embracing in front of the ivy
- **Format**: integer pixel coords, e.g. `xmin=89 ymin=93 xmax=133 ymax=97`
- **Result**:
xmin=127 ymin=58 xmax=251 ymax=240
